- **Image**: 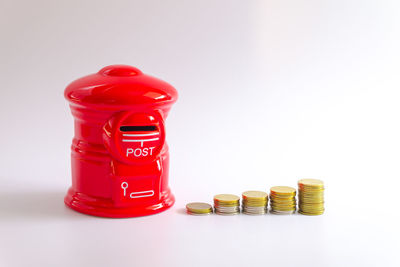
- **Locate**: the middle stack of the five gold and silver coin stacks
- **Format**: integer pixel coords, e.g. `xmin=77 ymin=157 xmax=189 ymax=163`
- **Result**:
xmin=242 ymin=191 xmax=268 ymax=215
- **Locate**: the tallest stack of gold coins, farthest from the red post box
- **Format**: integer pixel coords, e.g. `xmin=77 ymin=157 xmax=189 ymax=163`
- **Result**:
xmin=298 ymin=179 xmax=325 ymax=215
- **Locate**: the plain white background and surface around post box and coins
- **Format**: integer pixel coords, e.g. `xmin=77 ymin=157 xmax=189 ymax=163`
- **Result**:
xmin=0 ymin=0 xmax=400 ymax=267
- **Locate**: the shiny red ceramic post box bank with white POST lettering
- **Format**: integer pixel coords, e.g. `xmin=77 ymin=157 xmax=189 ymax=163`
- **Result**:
xmin=64 ymin=65 xmax=178 ymax=218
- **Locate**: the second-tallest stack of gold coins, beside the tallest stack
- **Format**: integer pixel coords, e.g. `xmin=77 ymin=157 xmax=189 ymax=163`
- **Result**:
xmin=269 ymin=186 xmax=296 ymax=214
